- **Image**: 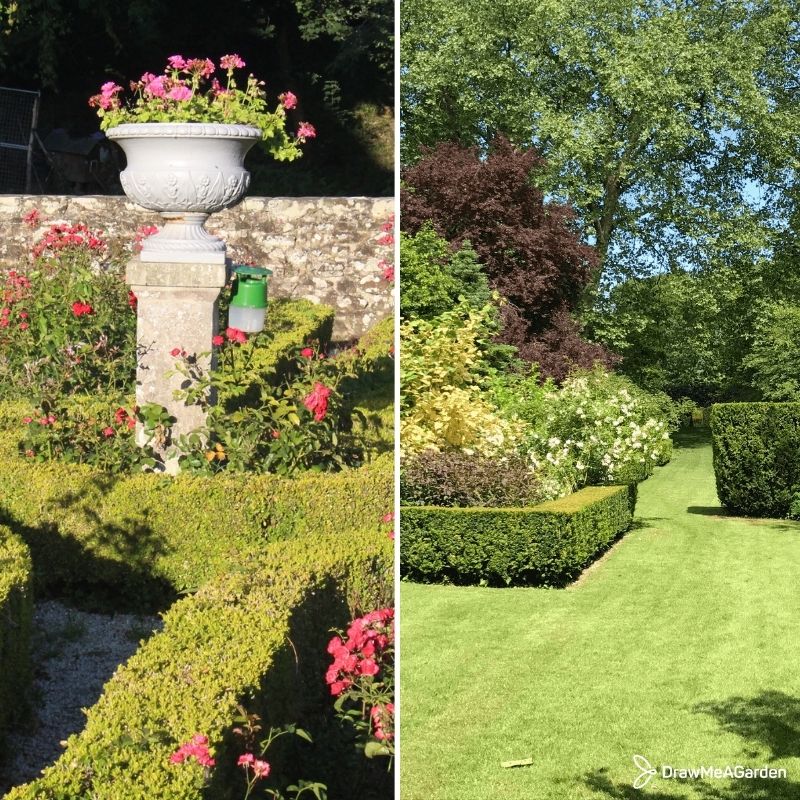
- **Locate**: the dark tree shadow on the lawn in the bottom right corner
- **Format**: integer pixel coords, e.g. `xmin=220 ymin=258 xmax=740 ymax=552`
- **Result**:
xmin=584 ymin=691 xmax=800 ymax=800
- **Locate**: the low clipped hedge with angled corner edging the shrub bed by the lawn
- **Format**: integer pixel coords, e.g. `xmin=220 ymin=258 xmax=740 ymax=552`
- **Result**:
xmin=400 ymin=486 xmax=635 ymax=585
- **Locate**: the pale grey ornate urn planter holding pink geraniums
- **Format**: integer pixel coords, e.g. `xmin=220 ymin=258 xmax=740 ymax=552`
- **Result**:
xmin=106 ymin=122 xmax=261 ymax=264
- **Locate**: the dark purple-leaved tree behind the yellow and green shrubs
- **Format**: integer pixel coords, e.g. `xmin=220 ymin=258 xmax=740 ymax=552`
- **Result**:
xmin=401 ymin=137 xmax=609 ymax=379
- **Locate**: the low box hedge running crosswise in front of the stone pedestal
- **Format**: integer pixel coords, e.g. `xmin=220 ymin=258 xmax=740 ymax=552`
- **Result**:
xmin=0 ymin=437 xmax=393 ymax=610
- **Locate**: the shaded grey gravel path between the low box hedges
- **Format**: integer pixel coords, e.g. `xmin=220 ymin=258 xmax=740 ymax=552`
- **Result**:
xmin=0 ymin=602 xmax=162 ymax=796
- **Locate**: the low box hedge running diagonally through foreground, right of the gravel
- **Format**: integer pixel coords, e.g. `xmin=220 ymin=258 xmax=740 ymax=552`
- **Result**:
xmin=6 ymin=526 xmax=393 ymax=800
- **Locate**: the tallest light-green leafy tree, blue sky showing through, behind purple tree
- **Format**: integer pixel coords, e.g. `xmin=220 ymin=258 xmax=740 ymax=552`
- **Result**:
xmin=401 ymin=0 xmax=800 ymax=282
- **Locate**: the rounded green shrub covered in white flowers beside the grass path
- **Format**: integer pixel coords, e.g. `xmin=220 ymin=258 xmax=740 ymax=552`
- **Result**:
xmin=529 ymin=367 xmax=672 ymax=484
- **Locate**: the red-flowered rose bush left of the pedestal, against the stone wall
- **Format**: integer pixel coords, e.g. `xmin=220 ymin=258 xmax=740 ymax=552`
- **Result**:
xmin=0 ymin=223 xmax=136 ymax=404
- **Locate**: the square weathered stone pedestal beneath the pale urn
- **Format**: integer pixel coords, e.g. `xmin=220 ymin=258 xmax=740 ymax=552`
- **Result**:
xmin=126 ymin=257 xmax=227 ymax=473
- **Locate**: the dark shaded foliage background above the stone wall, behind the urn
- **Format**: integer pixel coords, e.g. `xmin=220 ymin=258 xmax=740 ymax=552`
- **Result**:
xmin=0 ymin=0 xmax=394 ymax=196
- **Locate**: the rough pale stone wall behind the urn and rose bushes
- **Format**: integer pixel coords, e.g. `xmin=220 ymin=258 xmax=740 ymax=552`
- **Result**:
xmin=0 ymin=195 xmax=394 ymax=341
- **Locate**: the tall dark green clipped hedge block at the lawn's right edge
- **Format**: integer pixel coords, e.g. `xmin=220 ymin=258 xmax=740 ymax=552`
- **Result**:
xmin=710 ymin=403 xmax=800 ymax=517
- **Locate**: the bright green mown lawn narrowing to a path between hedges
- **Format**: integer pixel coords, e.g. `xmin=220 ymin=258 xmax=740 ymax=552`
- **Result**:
xmin=400 ymin=441 xmax=800 ymax=800
